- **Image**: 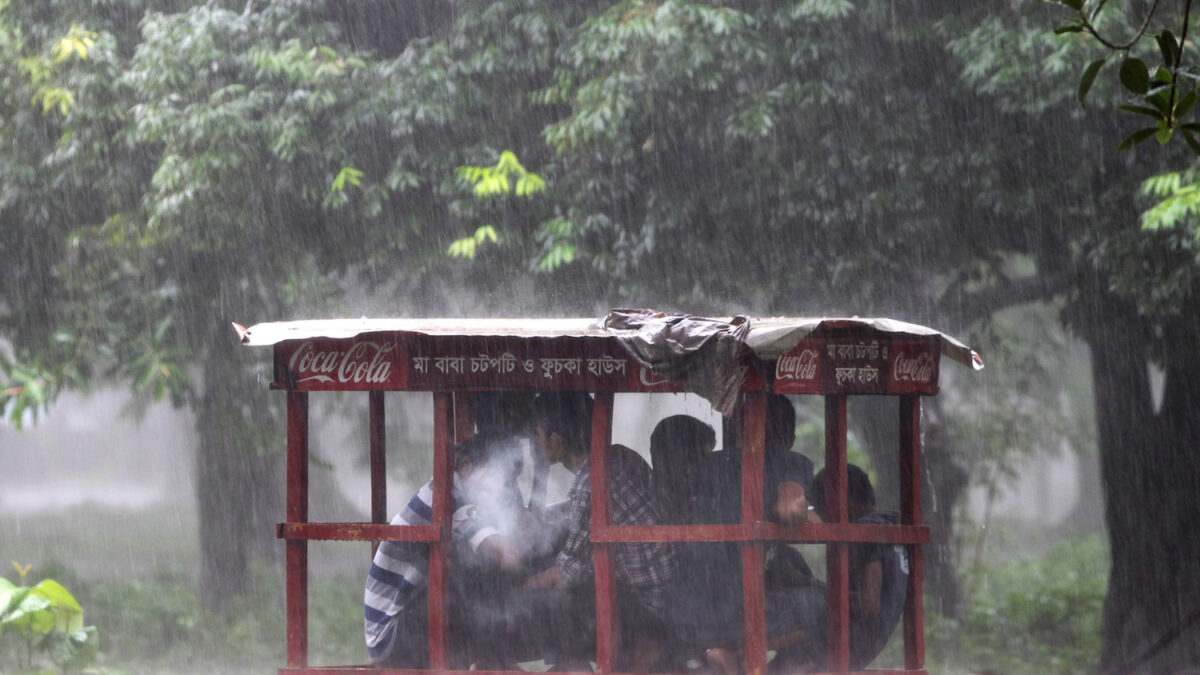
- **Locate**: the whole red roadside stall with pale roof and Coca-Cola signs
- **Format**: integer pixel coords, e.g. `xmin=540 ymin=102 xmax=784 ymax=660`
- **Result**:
xmin=234 ymin=310 xmax=983 ymax=675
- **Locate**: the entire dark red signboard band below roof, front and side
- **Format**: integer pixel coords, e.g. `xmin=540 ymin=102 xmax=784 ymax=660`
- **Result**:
xmin=275 ymin=333 xmax=940 ymax=394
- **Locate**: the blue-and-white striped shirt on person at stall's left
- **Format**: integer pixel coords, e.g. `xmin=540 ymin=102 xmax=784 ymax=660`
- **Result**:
xmin=362 ymin=479 xmax=498 ymax=663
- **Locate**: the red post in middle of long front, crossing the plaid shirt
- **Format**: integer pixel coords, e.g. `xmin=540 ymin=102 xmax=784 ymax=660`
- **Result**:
xmin=590 ymin=392 xmax=620 ymax=673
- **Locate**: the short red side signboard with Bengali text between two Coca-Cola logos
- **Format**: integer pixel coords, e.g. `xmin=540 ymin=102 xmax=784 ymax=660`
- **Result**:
xmin=773 ymin=334 xmax=940 ymax=394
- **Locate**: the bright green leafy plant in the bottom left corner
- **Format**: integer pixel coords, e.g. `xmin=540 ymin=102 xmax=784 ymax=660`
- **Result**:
xmin=0 ymin=562 xmax=100 ymax=673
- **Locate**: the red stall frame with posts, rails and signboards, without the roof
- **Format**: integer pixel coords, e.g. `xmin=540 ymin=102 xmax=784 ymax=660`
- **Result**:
xmin=272 ymin=325 xmax=938 ymax=675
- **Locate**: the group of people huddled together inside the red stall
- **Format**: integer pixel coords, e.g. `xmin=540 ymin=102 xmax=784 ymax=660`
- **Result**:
xmin=365 ymin=393 xmax=908 ymax=675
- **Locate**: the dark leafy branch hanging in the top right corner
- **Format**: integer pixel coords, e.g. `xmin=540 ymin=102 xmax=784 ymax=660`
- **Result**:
xmin=1055 ymin=0 xmax=1200 ymax=155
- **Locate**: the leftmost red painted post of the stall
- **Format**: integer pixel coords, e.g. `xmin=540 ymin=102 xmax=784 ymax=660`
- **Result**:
xmin=286 ymin=392 xmax=308 ymax=668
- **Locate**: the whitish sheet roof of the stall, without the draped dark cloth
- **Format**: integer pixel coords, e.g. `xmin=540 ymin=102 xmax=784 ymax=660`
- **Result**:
xmin=234 ymin=317 xmax=983 ymax=370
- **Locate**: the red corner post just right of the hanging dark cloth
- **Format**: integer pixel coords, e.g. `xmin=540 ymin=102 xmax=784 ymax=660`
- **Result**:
xmin=742 ymin=392 xmax=767 ymax=675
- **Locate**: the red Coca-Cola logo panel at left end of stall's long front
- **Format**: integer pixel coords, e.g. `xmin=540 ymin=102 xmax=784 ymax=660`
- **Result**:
xmin=281 ymin=336 xmax=404 ymax=389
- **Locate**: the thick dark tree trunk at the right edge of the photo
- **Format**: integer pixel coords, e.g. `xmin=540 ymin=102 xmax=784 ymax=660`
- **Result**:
xmin=1087 ymin=293 xmax=1200 ymax=673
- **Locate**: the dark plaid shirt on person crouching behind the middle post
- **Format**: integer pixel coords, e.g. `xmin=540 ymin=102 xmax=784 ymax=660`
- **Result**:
xmin=558 ymin=446 xmax=676 ymax=615
